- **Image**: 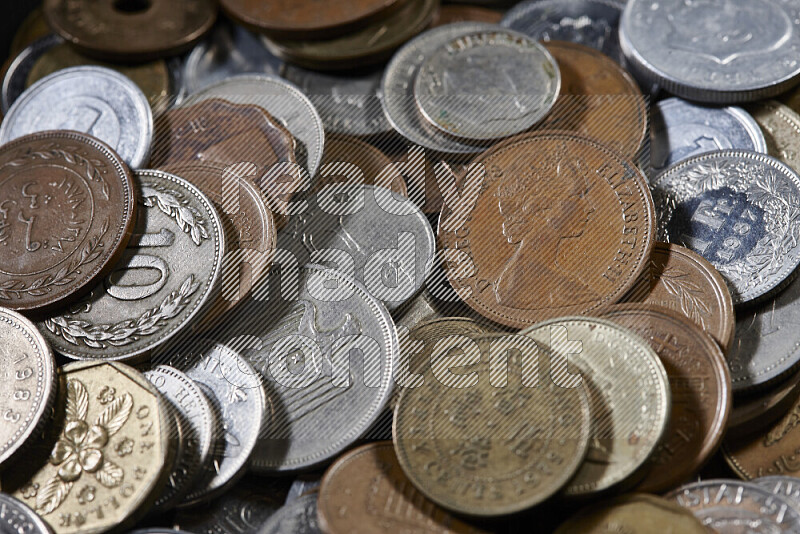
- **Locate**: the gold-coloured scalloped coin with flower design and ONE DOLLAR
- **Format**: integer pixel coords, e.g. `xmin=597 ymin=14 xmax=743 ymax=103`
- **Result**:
xmin=2 ymin=362 xmax=171 ymax=534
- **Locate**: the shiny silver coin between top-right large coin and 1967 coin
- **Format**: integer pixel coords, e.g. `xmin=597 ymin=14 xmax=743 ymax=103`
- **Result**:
xmin=650 ymin=98 xmax=767 ymax=173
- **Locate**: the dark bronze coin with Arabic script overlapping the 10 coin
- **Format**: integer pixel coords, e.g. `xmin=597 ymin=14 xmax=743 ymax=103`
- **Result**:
xmin=0 ymin=131 xmax=135 ymax=311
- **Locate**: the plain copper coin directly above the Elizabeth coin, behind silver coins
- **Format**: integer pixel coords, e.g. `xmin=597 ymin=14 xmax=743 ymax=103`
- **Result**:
xmin=537 ymin=41 xmax=647 ymax=157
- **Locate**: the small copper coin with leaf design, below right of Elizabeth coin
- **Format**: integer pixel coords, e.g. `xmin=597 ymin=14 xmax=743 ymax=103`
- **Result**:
xmin=624 ymin=242 xmax=736 ymax=352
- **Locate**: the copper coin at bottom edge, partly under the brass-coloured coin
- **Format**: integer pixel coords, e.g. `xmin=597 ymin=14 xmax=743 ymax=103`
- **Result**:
xmin=317 ymin=441 xmax=484 ymax=534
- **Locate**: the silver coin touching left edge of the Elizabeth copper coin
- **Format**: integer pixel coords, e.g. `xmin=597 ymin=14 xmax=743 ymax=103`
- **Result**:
xmin=278 ymin=184 xmax=436 ymax=311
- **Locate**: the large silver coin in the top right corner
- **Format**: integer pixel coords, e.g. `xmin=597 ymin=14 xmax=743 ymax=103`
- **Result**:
xmin=620 ymin=0 xmax=800 ymax=104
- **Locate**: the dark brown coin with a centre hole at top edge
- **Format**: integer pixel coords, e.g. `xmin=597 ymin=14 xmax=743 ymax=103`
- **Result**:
xmin=44 ymin=0 xmax=217 ymax=61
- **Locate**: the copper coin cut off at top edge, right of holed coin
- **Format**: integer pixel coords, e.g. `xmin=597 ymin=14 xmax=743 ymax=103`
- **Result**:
xmin=220 ymin=0 xmax=407 ymax=40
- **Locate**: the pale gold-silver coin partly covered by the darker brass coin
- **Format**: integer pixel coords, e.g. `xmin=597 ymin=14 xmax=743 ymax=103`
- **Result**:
xmin=521 ymin=317 xmax=672 ymax=496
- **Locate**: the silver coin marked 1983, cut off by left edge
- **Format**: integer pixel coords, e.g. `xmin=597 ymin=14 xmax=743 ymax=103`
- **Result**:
xmin=0 ymin=308 xmax=57 ymax=464
